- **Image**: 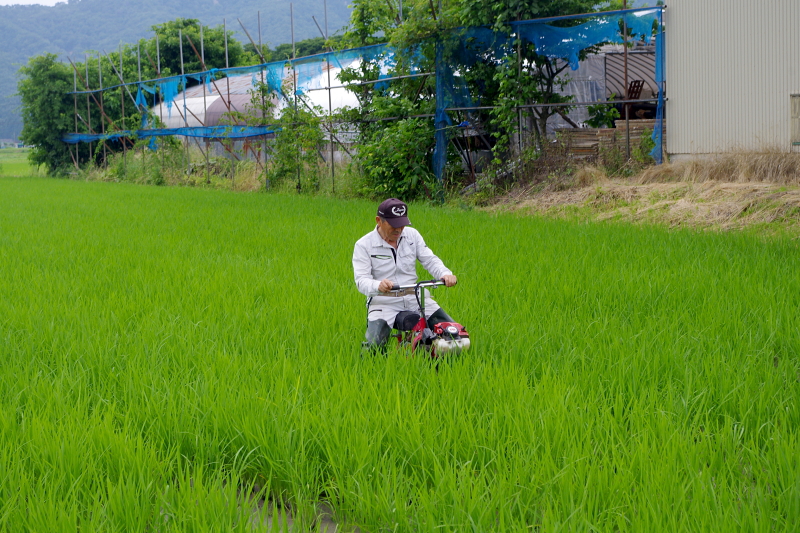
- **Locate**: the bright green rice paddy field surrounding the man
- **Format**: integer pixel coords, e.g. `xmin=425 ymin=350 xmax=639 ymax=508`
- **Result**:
xmin=0 ymin=178 xmax=800 ymax=532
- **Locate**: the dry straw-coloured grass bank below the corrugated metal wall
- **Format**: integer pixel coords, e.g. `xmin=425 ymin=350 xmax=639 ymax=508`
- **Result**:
xmin=490 ymin=152 xmax=800 ymax=232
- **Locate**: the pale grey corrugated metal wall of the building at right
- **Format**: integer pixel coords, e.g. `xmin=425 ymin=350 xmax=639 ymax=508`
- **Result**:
xmin=664 ymin=0 xmax=800 ymax=154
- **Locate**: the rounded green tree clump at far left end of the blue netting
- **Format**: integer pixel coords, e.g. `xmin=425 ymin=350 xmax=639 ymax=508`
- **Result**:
xmin=17 ymin=19 xmax=255 ymax=172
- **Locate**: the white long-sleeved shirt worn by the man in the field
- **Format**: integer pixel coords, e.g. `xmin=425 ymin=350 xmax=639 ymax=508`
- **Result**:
xmin=353 ymin=226 xmax=452 ymax=296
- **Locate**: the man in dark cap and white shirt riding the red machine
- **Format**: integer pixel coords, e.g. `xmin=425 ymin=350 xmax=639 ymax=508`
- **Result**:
xmin=353 ymin=198 xmax=458 ymax=349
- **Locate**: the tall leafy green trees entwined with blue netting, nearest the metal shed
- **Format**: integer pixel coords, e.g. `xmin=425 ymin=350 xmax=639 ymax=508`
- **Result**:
xmin=340 ymin=0 xmax=608 ymax=197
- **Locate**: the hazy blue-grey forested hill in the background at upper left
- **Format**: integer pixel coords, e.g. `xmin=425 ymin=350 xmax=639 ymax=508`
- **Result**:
xmin=0 ymin=0 xmax=350 ymax=138
